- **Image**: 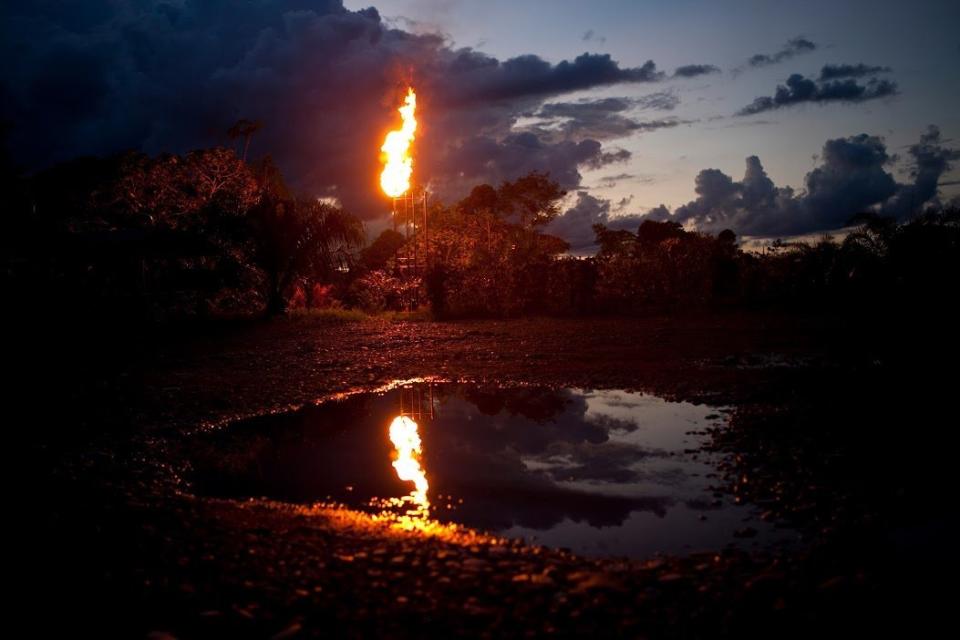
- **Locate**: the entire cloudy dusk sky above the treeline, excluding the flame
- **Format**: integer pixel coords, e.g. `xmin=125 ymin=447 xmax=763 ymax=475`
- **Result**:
xmin=0 ymin=0 xmax=960 ymax=250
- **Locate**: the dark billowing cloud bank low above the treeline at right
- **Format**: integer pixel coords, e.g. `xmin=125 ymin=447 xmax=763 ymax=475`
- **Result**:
xmin=647 ymin=127 xmax=960 ymax=237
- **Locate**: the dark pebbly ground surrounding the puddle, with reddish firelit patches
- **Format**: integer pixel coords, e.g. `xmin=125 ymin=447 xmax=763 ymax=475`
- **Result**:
xmin=16 ymin=314 xmax=956 ymax=638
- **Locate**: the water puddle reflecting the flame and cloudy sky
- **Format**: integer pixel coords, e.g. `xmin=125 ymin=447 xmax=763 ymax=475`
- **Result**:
xmin=193 ymin=383 xmax=794 ymax=557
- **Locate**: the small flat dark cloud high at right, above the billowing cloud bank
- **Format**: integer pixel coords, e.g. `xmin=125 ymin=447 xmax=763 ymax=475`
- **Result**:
xmin=736 ymin=73 xmax=898 ymax=116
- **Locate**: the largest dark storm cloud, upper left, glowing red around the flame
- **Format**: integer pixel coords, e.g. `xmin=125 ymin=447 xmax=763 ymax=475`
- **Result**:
xmin=0 ymin=0 xmax=664 ymax=217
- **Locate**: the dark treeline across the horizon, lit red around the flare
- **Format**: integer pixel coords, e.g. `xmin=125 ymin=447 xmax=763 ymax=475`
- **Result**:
xmin=2 ymin=147 xmax=960 ymax=326
